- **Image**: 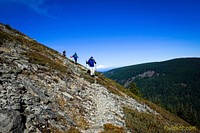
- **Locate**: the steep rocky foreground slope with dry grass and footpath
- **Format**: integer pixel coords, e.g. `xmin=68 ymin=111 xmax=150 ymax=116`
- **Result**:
xmin=0 ymin=24 xmax=198 ymax=133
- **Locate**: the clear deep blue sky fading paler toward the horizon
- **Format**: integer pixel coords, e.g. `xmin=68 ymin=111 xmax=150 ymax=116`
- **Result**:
xmin=0 ymin=0 xmax=200 ymax=70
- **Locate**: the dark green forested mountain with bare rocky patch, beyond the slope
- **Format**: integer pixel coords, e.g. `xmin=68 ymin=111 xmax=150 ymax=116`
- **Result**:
xmin=104 ymin=58 xmax=200 ymax=127
